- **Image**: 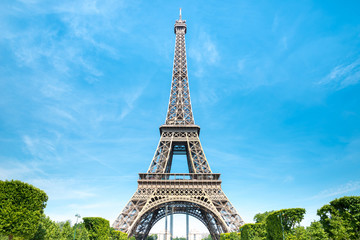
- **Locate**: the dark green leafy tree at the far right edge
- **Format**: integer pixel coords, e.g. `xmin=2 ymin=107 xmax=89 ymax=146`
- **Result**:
xmin=317 ymin=196 xmax=360 ymax=239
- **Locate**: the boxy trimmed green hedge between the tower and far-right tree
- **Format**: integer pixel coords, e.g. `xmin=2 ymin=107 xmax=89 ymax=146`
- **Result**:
xmin=266 ymin=208 xmax=306 ymax=240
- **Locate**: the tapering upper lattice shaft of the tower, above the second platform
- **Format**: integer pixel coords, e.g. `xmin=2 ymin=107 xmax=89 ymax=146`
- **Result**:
xmin=165 ymin=24 xmax=194 ymax=125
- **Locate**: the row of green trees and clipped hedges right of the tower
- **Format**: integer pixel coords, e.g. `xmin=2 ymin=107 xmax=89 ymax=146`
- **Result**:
xmin=220 ymin=196 xmax=360 ymax=240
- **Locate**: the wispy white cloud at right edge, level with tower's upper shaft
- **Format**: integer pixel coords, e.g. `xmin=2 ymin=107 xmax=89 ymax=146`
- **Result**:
xmin=318 ymin=58 xmax=360 ymax=90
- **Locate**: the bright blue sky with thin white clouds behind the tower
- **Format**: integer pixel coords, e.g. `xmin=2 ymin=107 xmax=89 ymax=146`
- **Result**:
xmin=0 ymin=0 xmax=360 ymax=236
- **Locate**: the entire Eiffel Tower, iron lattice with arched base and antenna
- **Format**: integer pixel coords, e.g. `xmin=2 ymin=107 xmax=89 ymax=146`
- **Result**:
xmin=113 ymin=9 xmax=244 ymax=240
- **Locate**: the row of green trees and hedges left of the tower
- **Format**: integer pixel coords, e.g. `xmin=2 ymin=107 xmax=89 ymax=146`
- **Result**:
xmin=0 ymin=180 xmax=128 ymax=240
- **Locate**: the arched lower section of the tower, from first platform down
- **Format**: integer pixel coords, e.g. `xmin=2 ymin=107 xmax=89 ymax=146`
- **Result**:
xmin=113 ymin=176 xmax=244 ymax=239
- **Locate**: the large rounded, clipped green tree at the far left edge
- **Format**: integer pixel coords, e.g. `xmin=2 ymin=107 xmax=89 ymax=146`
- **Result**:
xmin=0 ymin=180 xmax=48 ymax=239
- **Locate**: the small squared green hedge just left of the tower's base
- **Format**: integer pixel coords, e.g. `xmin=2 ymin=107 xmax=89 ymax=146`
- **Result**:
xmin=83 ymin=217 xmax=110 ymax=240
